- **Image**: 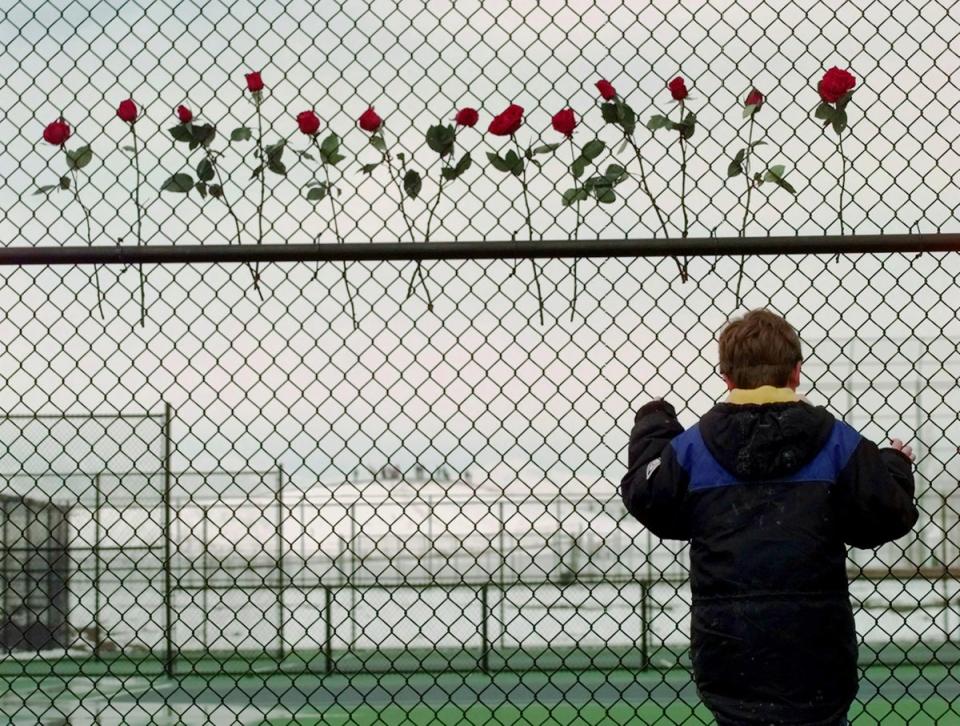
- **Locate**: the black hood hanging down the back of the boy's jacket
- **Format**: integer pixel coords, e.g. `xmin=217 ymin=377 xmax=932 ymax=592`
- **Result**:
xmin=700 ymin=401 xmax=835 ymax=481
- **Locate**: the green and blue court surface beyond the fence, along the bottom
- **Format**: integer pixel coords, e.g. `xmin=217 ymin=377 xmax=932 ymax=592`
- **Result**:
xmin=0 ymin=662 xmax=960 ymax=726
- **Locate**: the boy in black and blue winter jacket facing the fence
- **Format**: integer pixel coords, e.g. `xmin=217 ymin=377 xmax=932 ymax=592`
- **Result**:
xmin=620 ymin=310 xmax=918 ymax=726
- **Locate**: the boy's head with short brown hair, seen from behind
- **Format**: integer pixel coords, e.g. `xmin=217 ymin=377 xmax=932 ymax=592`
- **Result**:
xmin=720 ymin=310 xmax=803 ymax=396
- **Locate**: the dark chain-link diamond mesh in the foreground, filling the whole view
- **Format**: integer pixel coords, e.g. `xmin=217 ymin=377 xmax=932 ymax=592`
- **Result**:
xmin=0 ymin=0 xmax=960 ymax=725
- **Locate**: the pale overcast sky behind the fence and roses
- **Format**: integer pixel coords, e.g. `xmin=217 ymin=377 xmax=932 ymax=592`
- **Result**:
xmin=0 ymin=0 xmax=960 ymax=516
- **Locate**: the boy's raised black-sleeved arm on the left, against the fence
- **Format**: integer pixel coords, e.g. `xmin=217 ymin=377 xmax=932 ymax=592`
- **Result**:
xmin=620 ymin=400 xmax=690 ymax=539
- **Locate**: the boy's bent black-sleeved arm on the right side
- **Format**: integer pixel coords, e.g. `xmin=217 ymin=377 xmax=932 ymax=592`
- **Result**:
xmin=837 ymin=438 xmax=919 ymax=549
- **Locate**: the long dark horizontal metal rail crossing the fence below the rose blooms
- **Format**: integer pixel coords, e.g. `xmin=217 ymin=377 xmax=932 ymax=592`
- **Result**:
xmin=0 ymin=233 xmax=960 ymax=265
